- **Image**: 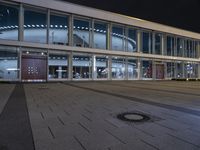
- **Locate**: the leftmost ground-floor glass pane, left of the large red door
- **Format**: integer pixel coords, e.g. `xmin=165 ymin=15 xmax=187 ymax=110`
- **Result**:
xmin=0 ymin=46 xmax=19 ymax=80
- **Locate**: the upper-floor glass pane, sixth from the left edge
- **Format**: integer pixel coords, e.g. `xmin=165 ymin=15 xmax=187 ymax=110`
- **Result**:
xmin=112 ymin=26 xmax=124 ymax=51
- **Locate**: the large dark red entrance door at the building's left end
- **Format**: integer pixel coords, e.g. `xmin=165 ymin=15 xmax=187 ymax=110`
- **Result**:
xmin=21 ymin=54 xmax=47 ymax=82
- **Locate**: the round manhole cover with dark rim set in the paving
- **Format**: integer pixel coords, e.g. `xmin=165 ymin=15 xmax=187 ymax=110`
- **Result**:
xmin=117 ymin=112 xmax=150 ymax=122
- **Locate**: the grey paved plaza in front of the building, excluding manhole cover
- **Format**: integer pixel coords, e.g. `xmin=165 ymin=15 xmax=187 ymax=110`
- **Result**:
xmin=0 ymin=81 xmax=200 ymax=150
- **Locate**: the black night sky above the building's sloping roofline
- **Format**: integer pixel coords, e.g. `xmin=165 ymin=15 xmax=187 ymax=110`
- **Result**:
xmin=60 ymin=0 xmax=200 ymax=33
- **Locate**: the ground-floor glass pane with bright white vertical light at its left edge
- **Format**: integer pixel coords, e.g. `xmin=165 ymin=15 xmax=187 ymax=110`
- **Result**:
xmin=94 ymin=56 xmax=109 ymax=79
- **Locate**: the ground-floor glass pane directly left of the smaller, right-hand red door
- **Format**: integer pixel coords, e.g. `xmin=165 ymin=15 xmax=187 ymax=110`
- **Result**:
xmin=142 ymin=60 xmax=152 ymax=78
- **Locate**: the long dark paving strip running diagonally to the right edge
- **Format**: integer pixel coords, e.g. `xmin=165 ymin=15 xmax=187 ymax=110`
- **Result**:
xmin=63 ymin=83 xmax=200 ymax=116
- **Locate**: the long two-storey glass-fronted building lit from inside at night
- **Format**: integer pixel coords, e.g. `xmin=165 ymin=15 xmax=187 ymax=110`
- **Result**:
xmin=0 ymin=0 xmax=200 ymax=81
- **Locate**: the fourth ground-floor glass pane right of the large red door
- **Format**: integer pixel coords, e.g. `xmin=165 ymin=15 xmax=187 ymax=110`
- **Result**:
xmin=112 ymin=57 xmax=125 ymax=79
